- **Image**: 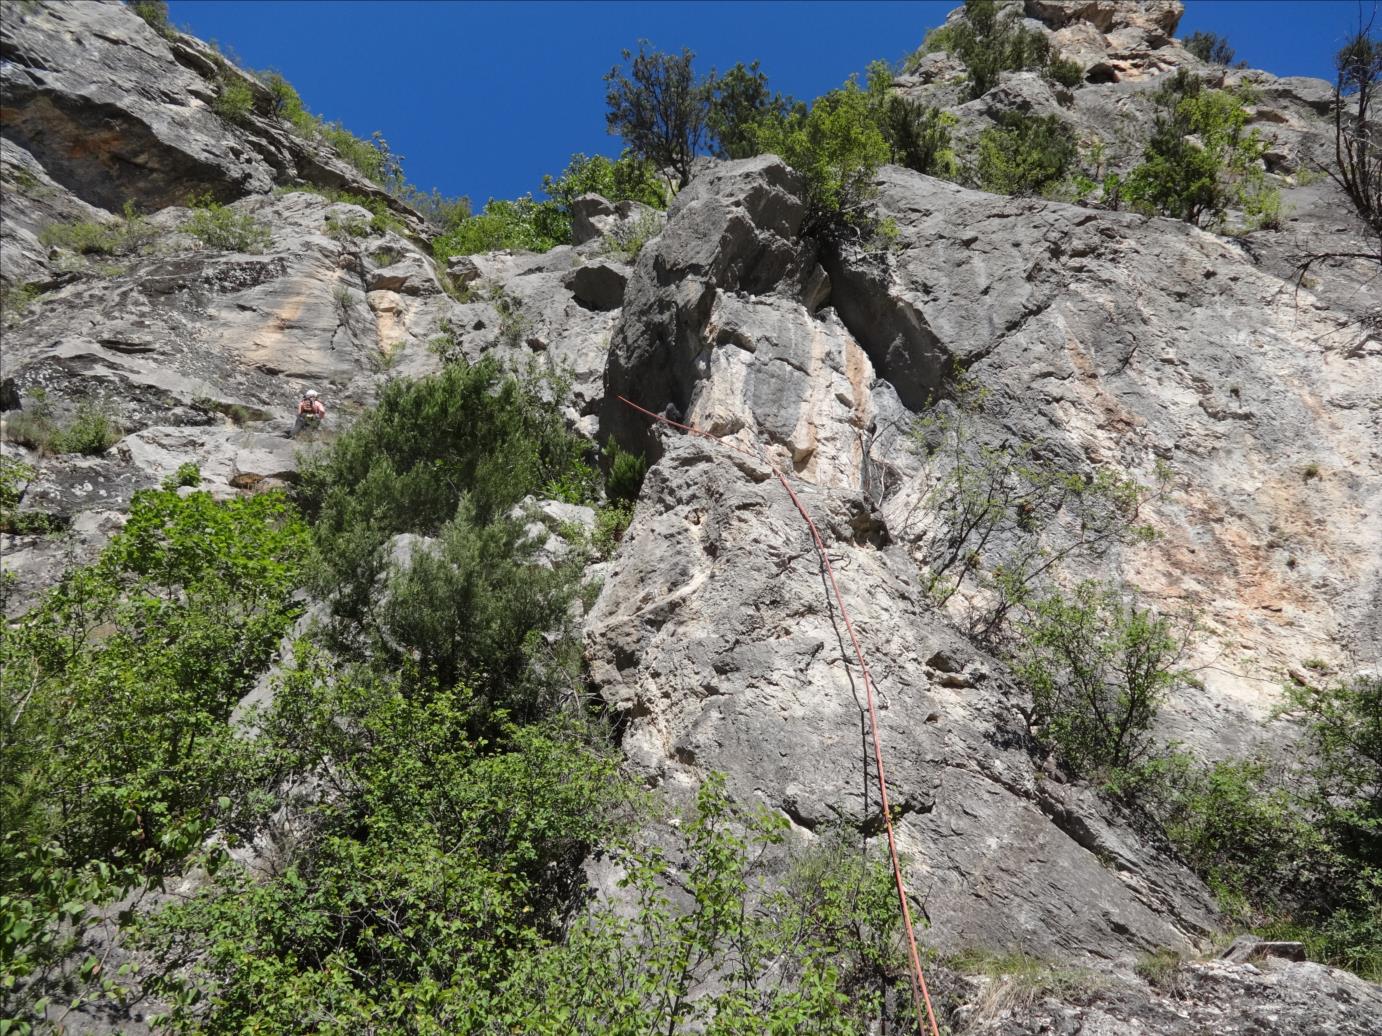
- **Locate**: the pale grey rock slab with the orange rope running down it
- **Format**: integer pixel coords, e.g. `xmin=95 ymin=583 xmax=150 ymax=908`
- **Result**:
xmin=586 ymin=439 xmax=1213 ymax=957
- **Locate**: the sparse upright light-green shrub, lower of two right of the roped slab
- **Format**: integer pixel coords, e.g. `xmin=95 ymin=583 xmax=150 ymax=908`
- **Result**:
xmin=1016 ymin=582 xmax=1189 ymax=776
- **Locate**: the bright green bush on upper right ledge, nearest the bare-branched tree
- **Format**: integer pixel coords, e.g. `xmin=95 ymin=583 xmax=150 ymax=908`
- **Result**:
xmin=1122 ymin=69 xmax=1281 ymax=225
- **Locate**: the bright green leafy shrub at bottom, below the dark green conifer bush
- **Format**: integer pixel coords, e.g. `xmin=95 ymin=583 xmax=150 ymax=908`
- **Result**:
xmin=145 ymin=660 xmax=626 ymax=1033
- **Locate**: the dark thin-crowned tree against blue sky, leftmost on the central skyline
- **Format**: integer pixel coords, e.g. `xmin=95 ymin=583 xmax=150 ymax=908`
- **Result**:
xmin=605 ymin=40 xmax=708 ymax=189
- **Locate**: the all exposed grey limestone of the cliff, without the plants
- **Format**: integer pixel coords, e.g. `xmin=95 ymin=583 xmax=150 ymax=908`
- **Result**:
xmin=0 ymin=0 xmax=1382 ymax=1036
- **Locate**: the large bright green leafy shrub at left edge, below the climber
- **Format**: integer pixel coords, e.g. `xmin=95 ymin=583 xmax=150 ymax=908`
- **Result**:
xmin=0 ymin=490 xmax=307 ymax=1018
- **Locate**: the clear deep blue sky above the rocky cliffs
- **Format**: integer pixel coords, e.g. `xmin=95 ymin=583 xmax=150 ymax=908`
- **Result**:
xmin=169 ymin=0 xmax=1371 ymax=207
